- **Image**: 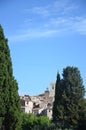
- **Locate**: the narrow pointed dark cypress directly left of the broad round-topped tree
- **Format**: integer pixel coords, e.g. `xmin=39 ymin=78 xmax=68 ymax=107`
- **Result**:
xmin=53 ymin=73 xmax=64 ymax=129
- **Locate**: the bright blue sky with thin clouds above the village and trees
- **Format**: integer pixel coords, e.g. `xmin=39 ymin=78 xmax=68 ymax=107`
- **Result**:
xmin=0 ymin=0 xmax=86 ymax=95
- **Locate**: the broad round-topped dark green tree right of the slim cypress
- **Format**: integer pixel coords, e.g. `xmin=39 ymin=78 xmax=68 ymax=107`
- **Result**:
xmin=62 ymin=67 xmax=85 ymax=128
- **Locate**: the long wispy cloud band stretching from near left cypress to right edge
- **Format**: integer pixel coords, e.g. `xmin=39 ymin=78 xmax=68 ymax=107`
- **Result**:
xmin=9 ymin=17 xmax=86 ymax=41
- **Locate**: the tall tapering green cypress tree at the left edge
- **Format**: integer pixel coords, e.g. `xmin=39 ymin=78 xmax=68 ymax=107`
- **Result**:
xmin=0 ymin=25 xmax=21 ymax=130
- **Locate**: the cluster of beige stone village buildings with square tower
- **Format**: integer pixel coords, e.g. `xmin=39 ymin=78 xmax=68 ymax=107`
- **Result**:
xmin=20 ymin=83 xmax=55 ymax=119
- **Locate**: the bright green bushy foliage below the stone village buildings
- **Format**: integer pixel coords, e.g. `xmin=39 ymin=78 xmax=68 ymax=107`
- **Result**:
xmin=21 ymin=113 xmax=51 ymax=130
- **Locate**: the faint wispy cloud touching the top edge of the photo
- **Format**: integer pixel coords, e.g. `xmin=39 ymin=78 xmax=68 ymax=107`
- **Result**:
xmin=25 ymin=0 xmax=79 ymax=17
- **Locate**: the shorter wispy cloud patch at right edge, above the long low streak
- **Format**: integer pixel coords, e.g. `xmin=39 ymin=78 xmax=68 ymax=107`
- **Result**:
xmin=45 ymin=16 xmax=86 ymax=33
